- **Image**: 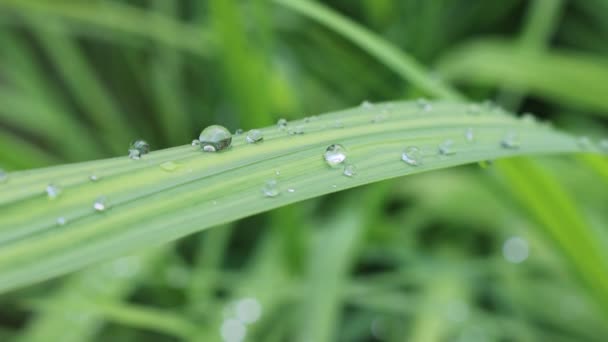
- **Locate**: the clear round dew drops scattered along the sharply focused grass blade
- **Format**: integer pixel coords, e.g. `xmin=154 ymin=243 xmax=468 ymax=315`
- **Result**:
xmin=0 ymin=99 xmax=608 ymax=225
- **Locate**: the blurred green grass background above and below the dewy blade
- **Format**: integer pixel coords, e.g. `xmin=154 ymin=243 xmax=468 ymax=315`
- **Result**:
xmin=0 ymin=0 xmax=608 ymax=342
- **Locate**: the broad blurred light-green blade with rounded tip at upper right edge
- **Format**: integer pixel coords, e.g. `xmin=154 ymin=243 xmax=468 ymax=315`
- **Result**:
xmin=438 ymin=40 xmax=608 ymax=115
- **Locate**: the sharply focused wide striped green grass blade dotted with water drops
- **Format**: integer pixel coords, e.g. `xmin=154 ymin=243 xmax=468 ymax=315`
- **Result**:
xmin=0 ymin=102 xmax=580 ymax=291
